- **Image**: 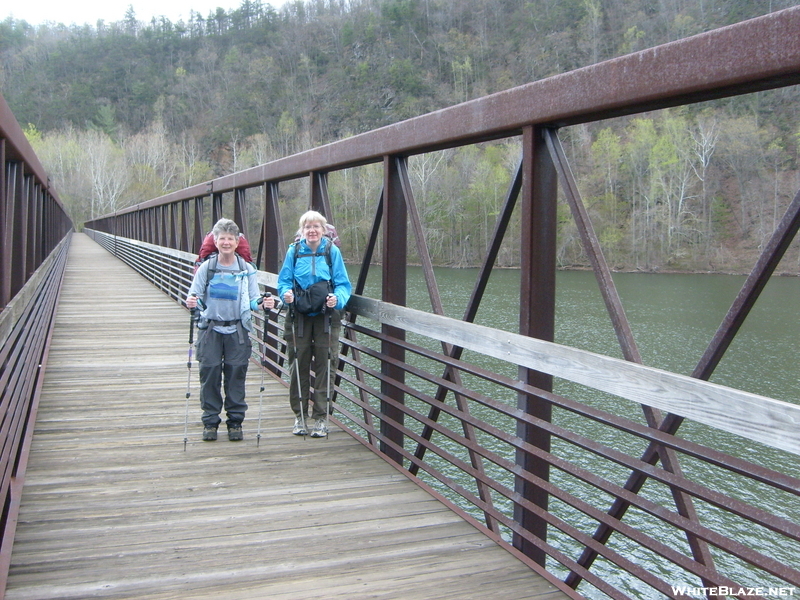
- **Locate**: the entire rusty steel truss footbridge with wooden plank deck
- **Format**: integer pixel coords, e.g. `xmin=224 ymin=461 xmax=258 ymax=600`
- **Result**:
xmin=0 ymin=8 xmax=800 ymax=599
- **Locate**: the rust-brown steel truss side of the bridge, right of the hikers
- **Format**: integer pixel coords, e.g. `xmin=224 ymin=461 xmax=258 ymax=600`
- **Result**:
xmin=87 ymin=7 xmax=800 ymax=598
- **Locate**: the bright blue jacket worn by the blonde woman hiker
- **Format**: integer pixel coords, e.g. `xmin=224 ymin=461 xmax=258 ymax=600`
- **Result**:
xmin=278 ymin=237 xmax=353 ymax=310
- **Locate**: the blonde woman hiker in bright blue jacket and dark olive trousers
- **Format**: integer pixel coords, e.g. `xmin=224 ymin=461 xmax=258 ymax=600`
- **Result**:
xmin=278 ymin=211 xmax=352 ymax=437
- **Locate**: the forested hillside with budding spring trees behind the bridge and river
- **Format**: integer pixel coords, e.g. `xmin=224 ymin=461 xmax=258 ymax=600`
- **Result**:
xmin=0 ymin=0 xmax=800 ymax=273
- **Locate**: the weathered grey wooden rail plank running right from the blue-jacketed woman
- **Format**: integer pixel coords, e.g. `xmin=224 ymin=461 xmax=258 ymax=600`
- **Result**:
xmin=348 ymin=296 xmax=800 ymax=455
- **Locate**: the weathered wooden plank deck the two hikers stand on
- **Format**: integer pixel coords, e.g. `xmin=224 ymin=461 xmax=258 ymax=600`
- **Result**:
xmin=5 ymin=235 xmax=566 ymax=600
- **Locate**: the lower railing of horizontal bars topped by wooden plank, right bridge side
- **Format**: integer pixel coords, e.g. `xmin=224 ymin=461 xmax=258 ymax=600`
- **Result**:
xmin=87 ymin=231 xmax=800 ymax=598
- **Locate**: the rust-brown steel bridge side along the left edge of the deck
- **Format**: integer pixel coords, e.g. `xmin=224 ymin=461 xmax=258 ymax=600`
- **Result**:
xmin=0 ymin=96 xmax=72 ymax=590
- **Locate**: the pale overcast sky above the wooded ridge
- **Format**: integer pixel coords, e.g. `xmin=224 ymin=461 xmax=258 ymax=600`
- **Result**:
xmin=0 ymin=0 xmax=283 ymax=26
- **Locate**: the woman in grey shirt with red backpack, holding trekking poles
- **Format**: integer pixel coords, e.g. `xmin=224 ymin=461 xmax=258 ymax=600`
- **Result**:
xmin=186 ymin=219 xmax=275 ymax=442
